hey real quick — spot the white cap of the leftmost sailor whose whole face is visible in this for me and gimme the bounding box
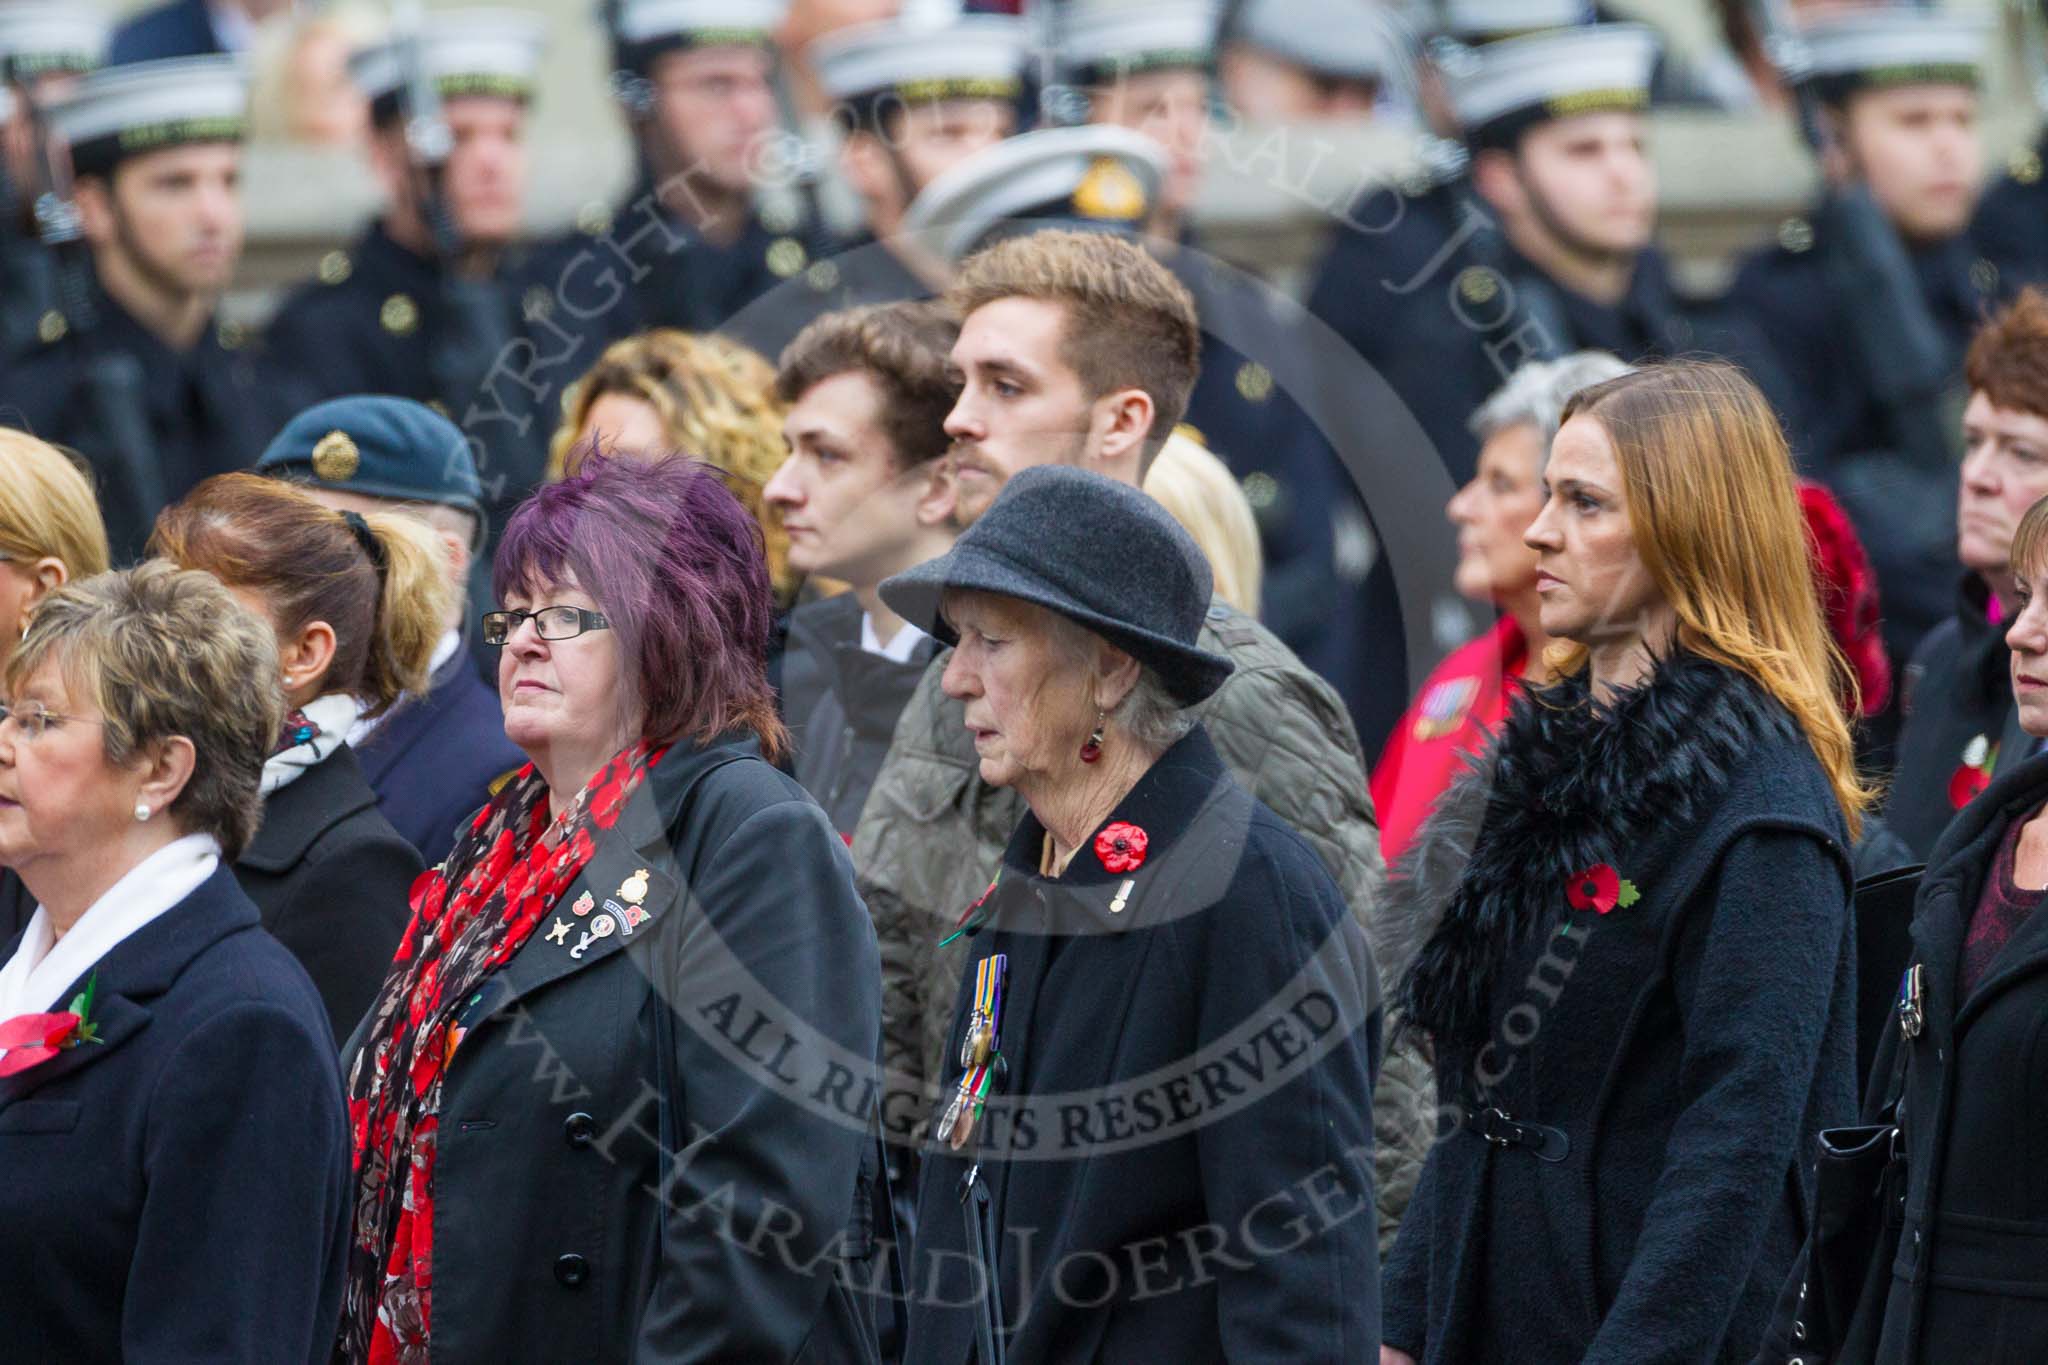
[49,55,248,174]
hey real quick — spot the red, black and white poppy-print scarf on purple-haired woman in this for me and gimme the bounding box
[334,741,664,1365]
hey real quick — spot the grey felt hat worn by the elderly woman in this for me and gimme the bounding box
[881,465,1233,706]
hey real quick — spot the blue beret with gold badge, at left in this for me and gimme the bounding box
[256,393,483,518]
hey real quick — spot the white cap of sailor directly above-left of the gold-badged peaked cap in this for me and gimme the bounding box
[809,14,1030,112]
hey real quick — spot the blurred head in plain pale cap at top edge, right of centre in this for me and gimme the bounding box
[1219,0,1407,123]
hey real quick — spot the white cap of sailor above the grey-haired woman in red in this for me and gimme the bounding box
[1446,25,1657,143]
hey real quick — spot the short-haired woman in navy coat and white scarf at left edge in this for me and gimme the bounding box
[0,561,348,1361]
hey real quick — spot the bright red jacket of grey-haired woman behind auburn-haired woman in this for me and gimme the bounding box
[1372,616,1528,866]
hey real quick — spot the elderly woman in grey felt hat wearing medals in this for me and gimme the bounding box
[881,467,1378,1365]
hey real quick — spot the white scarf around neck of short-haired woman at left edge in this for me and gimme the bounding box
[0,835,221,1019]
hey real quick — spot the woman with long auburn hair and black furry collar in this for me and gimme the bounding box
[1380,362,1870,1365]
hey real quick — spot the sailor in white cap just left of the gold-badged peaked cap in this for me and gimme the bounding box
[733,10,1030,356]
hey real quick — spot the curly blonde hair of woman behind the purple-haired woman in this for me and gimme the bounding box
[547,327,799,604]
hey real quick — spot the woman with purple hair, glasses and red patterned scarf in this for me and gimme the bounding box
[336,456,881,1363]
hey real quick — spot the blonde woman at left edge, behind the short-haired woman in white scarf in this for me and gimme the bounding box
[0,428,106,943]
